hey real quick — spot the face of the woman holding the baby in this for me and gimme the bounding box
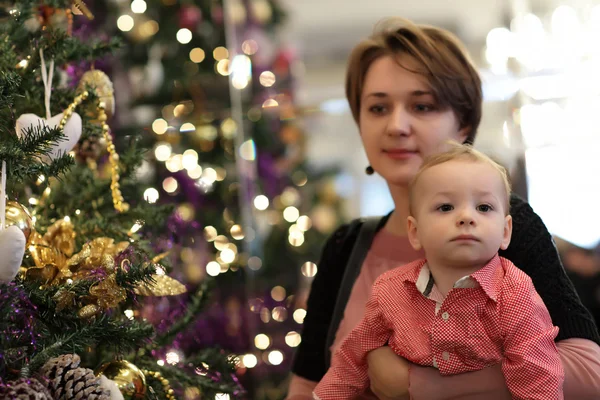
[359,56,468,186]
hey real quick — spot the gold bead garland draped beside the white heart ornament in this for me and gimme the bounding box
[58,90,129,212]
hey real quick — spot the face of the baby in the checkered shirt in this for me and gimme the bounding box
[413,160,512,267]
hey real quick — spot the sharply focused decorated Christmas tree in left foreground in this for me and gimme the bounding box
[0,0,242,399]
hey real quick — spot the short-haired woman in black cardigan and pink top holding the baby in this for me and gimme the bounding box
[288,19,600,400]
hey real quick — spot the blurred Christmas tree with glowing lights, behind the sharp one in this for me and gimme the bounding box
[93,0,340,399]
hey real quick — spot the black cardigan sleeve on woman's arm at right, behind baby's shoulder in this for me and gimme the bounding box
[500,196,600,344]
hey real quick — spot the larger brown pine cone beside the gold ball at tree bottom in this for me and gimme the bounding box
[41,354,110,400]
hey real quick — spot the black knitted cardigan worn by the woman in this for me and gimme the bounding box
[292,195,600,382]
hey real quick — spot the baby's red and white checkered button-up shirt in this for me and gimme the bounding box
[314,255,564,400]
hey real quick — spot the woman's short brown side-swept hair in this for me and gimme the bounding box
[346,18,483,143]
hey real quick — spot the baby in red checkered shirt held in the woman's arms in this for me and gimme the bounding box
[313,144,564,400]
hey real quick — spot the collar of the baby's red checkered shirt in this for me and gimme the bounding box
[405,254,503,301]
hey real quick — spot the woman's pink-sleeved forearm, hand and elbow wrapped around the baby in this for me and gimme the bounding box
[366,339,600,400]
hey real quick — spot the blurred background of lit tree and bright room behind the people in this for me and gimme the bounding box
[82,0,600,399]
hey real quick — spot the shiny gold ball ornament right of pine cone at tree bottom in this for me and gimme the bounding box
[96,360,146,400]
